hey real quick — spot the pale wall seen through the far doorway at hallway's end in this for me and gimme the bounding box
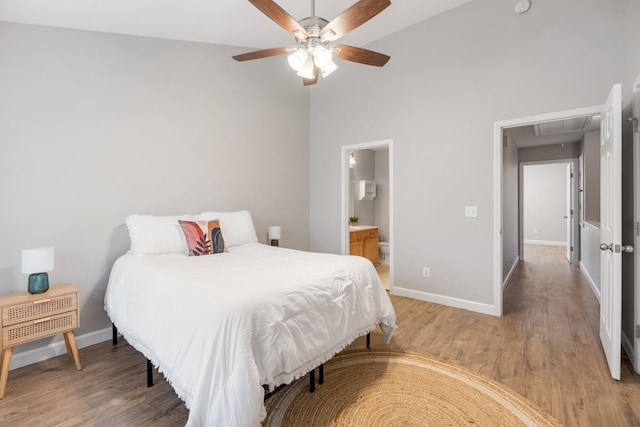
[522,163,567,244]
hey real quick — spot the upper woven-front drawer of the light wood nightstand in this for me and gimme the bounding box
[2,293,78,327]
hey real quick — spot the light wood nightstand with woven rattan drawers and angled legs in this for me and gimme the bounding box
[0,284,82,399]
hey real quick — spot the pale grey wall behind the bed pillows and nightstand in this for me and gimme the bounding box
[0,22,309,354]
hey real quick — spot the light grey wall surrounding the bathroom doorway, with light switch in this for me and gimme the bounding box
[311,0,623,312]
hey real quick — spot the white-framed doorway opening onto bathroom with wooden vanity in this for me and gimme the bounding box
[340,140,394,293]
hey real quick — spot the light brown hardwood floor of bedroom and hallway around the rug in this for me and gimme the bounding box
[0,246,640,426]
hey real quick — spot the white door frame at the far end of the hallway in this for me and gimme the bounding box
[518,157,580,265]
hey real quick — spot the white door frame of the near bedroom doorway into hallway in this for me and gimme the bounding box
[493,105,602,316]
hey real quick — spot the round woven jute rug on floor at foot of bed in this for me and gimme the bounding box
[263,350,560,427]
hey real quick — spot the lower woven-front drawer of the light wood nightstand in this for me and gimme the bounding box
[2,311,78,348]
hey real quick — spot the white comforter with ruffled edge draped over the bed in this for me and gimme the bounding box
[105,243,396,427]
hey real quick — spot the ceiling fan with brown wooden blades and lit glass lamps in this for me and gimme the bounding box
[233,0,391,86]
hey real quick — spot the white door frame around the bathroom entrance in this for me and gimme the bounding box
[340,139,395,294]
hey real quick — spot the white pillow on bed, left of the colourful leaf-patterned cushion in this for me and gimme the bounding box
[126,215,197,255]
